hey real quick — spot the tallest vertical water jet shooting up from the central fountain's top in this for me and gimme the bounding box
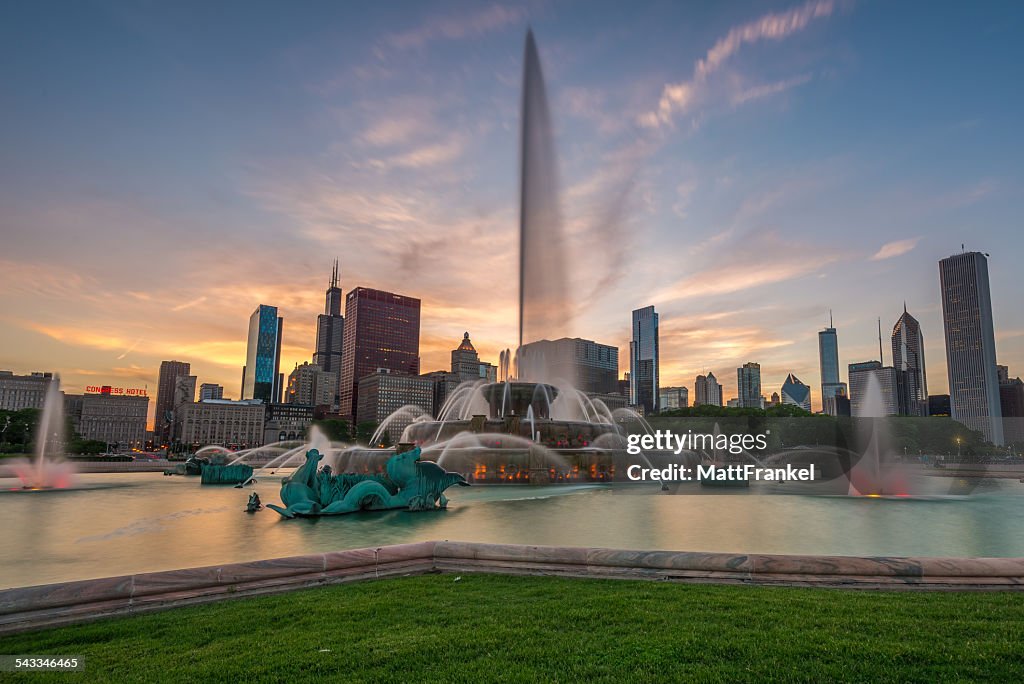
[514,31,571,382]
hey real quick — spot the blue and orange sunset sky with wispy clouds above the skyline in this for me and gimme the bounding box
[0,0,1024,421]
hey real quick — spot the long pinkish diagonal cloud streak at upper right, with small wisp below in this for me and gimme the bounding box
[639,0,836,128]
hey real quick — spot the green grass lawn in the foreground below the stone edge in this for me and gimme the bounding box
[0,574,1024,682]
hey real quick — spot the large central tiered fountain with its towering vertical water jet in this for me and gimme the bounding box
[391,31,655,483]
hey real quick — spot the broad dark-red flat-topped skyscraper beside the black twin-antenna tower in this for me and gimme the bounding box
[338,288,420,417]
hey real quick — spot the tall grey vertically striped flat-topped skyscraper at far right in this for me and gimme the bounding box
[939,252,1002,445]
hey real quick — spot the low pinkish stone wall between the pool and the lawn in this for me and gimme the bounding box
[0,542,1024,634]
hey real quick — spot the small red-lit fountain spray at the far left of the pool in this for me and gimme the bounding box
[9,377,76,490]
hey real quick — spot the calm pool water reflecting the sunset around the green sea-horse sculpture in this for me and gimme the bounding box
[0,473,1024,587]
